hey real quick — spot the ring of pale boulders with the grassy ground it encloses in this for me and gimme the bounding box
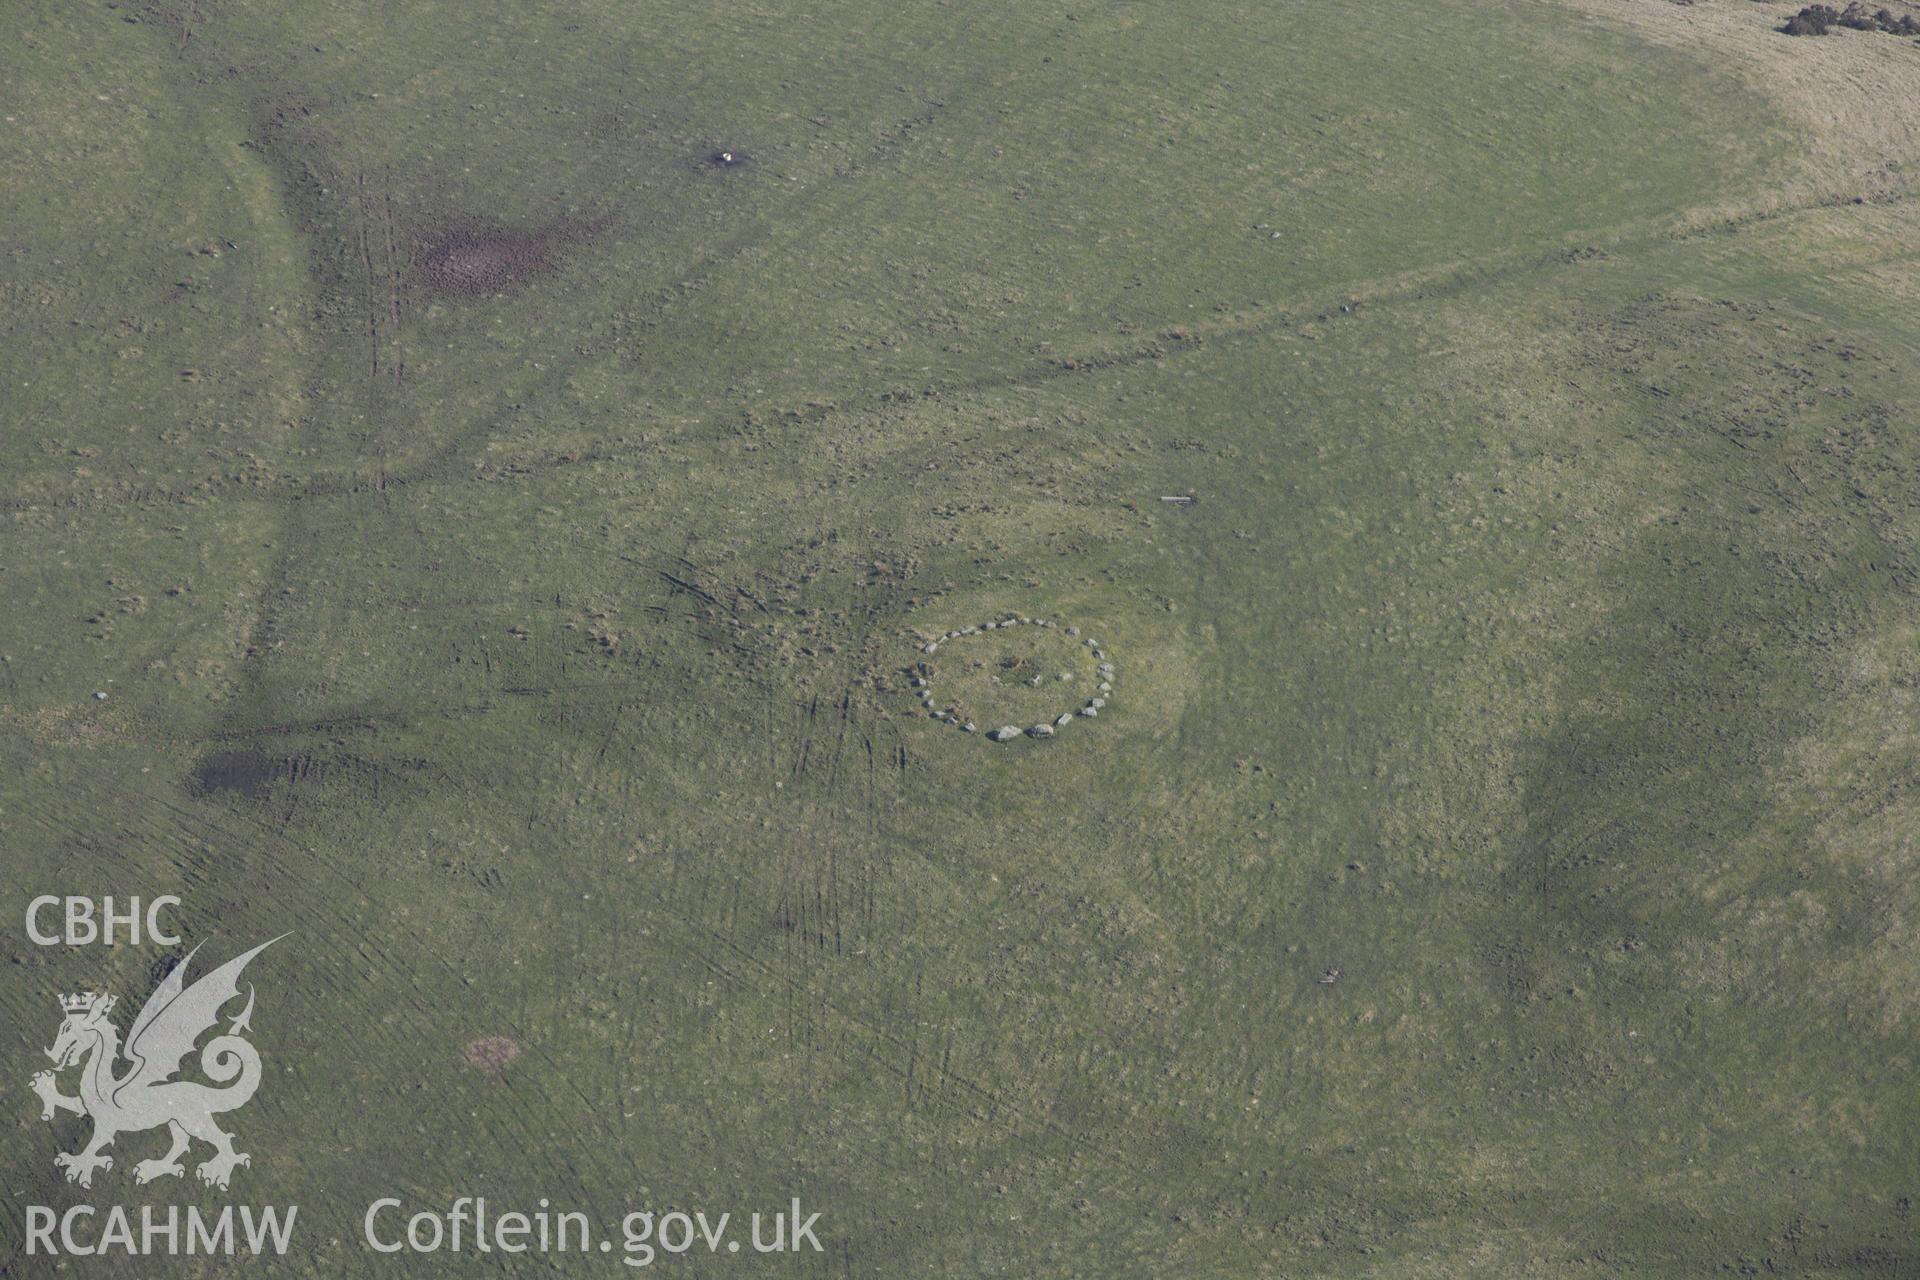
[908,614,1114,743]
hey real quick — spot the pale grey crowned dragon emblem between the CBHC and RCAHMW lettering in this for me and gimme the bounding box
[33,935,286,1188]
